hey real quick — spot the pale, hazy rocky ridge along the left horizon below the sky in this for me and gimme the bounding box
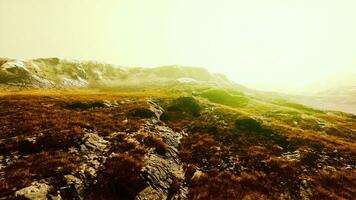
[0,58,234,88]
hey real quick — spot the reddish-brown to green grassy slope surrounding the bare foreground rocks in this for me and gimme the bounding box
[0,86,356,199]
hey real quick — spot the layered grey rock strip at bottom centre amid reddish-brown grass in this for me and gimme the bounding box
[137,122,188,200]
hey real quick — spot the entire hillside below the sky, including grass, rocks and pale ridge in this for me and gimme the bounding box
[0,59,356,200]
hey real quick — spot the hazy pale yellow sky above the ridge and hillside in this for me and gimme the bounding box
[0,0,356,91]
